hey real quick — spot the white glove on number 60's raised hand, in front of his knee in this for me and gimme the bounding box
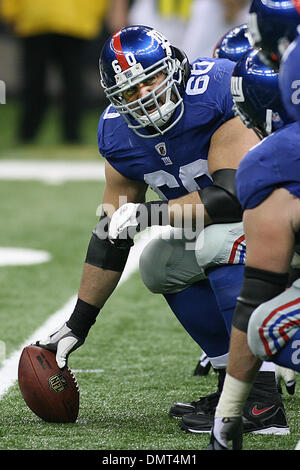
[108,202,140,244]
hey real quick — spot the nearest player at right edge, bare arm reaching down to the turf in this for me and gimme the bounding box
[208,0,300,450]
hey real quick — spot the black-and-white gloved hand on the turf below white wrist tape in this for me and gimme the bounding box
[206,417,243,450]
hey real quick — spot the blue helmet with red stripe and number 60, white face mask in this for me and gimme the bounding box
[99,26,190,138]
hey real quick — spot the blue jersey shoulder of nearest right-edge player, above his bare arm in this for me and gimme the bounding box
[236,123,300,210]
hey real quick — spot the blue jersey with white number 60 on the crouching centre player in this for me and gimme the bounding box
[98,58,235,200]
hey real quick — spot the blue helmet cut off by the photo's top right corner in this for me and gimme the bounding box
[248,0,300,70]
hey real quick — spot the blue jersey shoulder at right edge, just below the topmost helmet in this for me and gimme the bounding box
[279,36,300,122]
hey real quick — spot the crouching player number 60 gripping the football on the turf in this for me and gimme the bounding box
[39,22,286,430]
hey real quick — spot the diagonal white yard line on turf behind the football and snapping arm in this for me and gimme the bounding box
[0,227,161,399]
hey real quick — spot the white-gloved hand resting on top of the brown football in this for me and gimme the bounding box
[35,323,84,369]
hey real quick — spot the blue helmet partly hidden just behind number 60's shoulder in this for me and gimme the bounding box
[213,24,251,62]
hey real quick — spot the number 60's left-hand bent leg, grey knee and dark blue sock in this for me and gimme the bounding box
[140,229,229,367]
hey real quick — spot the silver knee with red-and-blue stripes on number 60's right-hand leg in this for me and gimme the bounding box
[195,222,246,269]
